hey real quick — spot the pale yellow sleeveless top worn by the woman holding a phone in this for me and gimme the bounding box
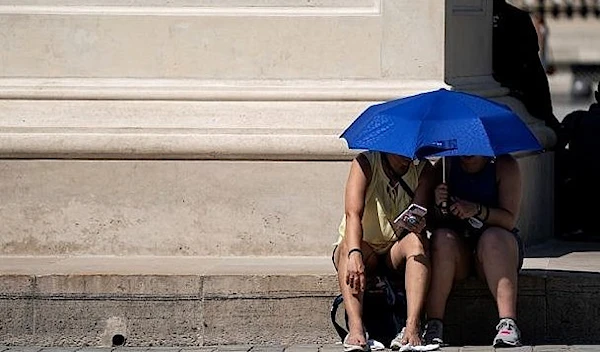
[334,152,426,254]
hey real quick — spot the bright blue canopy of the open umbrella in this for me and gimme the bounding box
[340,89,542,158]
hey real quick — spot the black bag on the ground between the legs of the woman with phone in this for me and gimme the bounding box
[331,276,406,346]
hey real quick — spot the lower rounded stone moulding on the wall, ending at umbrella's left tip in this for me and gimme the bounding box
[0,129,356,161]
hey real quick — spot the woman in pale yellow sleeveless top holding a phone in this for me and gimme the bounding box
[333,151,435,352]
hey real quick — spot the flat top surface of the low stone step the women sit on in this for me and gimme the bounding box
[0,240,600,277]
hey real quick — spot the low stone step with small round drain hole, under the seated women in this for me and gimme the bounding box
[0,242,600,346]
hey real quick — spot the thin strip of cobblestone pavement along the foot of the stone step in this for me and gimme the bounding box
[0,344,600,352]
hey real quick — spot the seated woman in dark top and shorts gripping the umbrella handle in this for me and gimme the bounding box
[424,155,523,347]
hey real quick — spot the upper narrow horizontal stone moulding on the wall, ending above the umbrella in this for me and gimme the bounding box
[0,78,448,102]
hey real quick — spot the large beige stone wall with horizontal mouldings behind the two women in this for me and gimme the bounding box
[0,0,553,255]
